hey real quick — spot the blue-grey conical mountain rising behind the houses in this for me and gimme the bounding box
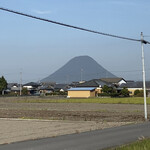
[42,56,116,83]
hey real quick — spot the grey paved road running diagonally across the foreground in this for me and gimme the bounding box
[0,122,150,150]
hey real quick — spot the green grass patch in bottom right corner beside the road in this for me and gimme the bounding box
[110,139,150,150]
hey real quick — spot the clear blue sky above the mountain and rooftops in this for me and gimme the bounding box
[0,0,150,83]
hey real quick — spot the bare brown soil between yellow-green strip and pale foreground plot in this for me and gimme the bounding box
[0,97,150,122]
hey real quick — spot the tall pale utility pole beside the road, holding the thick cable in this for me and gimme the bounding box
[141,32,147,120]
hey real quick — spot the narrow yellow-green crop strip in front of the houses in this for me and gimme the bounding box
[13,97,150,104]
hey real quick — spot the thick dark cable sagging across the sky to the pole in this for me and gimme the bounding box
[0,7,150,44]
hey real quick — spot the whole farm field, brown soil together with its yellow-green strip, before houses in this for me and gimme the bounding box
[0,97,150,122]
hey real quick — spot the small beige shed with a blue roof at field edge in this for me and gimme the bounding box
[68,87,95,98]
